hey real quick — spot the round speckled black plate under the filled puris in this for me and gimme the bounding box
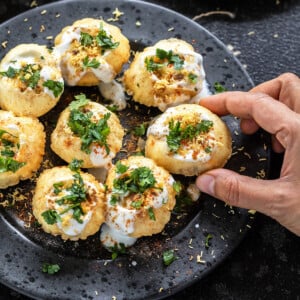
[0,0,269,299]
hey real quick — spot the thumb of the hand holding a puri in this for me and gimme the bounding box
[196,169,276,216]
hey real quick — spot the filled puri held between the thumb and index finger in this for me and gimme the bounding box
[145,104,232,176]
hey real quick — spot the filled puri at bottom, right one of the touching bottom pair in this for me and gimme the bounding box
[106,156,176,238]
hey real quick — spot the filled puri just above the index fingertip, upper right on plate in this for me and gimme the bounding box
[124,38,205,111]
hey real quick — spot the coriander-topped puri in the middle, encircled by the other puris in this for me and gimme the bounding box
[51,100,124,168]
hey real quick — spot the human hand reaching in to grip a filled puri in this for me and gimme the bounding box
[196,73,300,236]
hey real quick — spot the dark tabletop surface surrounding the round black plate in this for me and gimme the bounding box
[0,0,300,299]
